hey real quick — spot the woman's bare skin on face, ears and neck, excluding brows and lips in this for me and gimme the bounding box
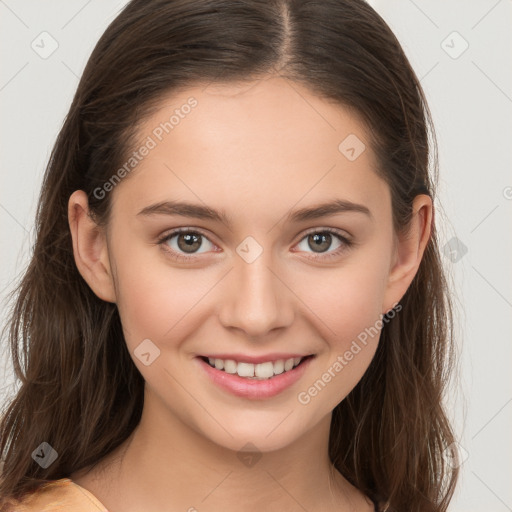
[69,77,432,512]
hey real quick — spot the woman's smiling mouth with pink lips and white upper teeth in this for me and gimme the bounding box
[194,354,315,400]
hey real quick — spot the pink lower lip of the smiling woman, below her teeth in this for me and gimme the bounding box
[195,356,314,400]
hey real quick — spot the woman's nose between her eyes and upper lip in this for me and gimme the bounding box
[219,251,294,340]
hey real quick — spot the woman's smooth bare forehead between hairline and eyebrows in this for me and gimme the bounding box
[114,78,387,226]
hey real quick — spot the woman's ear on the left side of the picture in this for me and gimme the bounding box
[68,190,116,303]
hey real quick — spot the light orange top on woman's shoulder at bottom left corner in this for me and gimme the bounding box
[6,478,108,512]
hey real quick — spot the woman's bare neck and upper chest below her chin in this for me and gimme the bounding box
[73,388,371,512]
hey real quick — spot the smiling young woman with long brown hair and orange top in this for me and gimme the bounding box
[0,0,457,512]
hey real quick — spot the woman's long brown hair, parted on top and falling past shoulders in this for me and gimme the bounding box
[0,0,457,512]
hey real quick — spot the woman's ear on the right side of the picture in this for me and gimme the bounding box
[382,194,434,314]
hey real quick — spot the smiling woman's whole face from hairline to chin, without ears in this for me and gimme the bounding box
[70,78,426,451]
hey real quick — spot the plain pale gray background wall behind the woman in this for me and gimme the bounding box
[0,0,512,512]
